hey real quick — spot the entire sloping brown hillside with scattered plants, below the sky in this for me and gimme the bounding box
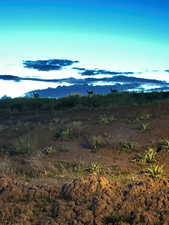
[0,92,169,225]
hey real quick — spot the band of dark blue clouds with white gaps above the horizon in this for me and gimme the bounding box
[0,59,169,97]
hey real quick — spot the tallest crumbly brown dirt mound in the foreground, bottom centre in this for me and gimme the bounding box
[58,174,118,225]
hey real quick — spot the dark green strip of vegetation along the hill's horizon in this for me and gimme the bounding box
[0,92,169,114]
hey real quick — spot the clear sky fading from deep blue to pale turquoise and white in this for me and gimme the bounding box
[0,0,169,96]
